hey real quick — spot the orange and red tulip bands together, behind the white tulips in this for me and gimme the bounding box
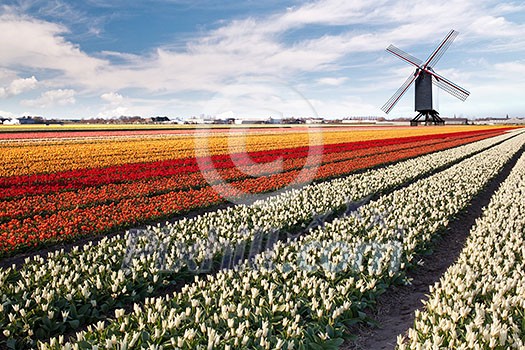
[0,128,504,256]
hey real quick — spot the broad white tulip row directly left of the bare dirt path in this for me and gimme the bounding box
[37,130,525,349]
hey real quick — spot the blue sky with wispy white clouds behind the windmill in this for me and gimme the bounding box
[0,0,525,119]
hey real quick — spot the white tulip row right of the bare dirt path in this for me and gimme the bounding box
[398,152,525,349]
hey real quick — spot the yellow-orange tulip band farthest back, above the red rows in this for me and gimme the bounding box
[0,127,506,177]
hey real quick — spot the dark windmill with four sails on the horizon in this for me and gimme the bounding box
[381,30,470,125]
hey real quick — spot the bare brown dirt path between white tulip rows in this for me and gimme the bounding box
[341,144,524,350]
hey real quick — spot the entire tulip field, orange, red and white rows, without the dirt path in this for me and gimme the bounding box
[0,126,525,349]
